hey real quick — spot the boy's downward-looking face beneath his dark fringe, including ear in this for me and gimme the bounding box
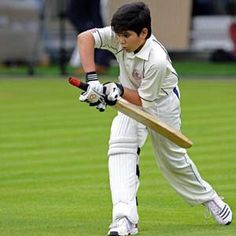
[116,28,148,52]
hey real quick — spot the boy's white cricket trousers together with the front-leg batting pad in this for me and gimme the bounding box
[108,87,217,224]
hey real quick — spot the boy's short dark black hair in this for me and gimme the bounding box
[111,2,152,38]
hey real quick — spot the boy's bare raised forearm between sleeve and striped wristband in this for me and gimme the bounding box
[77,31,96,73]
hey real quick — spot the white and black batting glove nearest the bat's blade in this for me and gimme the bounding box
[103,82,124,106]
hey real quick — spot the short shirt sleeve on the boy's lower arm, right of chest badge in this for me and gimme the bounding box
[138,60,167,108]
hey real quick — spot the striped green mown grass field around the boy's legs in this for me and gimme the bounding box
[0,78,236,236]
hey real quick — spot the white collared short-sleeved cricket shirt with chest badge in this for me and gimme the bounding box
[92,26,178,108]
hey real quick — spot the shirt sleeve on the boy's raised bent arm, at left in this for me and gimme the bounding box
[92,26,119,54]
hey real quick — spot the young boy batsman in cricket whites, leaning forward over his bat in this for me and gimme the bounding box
[78,2,232,236]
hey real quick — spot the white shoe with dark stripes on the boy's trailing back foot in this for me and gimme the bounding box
[204,196,233,225]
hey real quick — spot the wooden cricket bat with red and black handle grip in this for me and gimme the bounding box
[69,77,193,148]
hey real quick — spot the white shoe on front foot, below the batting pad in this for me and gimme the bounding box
[108,217,138,236]
